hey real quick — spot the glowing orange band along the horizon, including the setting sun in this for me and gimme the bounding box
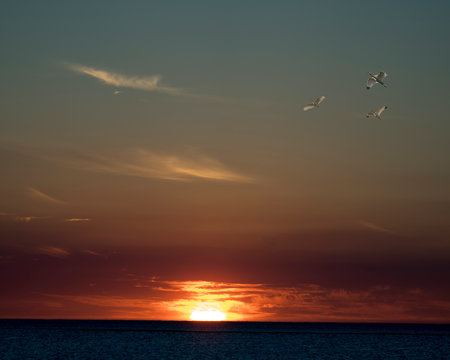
[0,278,448,323]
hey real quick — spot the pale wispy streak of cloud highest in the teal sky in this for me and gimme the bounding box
[67,64,184,95]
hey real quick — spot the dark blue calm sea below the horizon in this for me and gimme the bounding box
[0,320,450,360]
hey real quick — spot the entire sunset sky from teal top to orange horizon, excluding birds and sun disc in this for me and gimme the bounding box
[0,0,450,323]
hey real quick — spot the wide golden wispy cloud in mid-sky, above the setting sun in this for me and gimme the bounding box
[51,149,254,183]
